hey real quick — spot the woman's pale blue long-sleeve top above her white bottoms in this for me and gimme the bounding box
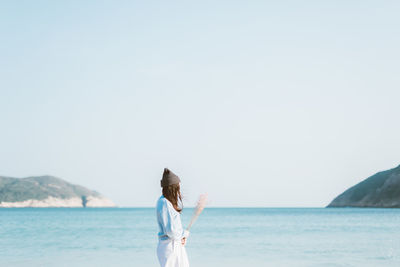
[157,195,189,240]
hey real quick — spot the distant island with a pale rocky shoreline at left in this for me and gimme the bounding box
[0,175,115,208]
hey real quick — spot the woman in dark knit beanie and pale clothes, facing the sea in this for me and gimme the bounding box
[157,168,189,267]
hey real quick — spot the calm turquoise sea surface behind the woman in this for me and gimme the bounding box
[0,208,400,267]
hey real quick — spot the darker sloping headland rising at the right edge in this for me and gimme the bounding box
[327,165,400,208]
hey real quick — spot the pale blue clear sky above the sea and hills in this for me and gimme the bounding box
[0,0,400,207]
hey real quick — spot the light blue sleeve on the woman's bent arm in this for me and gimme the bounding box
[160,202,184,240]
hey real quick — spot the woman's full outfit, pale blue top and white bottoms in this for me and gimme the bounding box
[157,196,189,267]
